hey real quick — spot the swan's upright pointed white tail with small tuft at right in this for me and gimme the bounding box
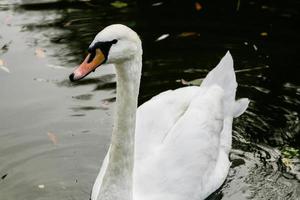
[201,51,249,117]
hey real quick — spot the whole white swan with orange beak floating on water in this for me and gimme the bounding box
[70,24,249,200]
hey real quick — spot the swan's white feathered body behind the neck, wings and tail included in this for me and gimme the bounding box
[134,53,248,200]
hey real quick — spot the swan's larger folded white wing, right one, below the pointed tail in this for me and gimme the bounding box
[134,86,231,200]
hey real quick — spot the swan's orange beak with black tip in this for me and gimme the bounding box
[69,49,105,81]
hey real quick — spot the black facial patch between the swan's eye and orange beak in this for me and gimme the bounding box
[88,39,118,63]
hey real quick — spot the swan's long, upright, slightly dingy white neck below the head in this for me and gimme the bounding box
[98,56,142,200]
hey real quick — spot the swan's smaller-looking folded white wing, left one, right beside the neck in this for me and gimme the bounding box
[135,87,199,159]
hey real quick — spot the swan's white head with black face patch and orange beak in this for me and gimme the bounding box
[69,24,142,81]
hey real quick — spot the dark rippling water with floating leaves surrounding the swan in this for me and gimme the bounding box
[0,0,300,200]
